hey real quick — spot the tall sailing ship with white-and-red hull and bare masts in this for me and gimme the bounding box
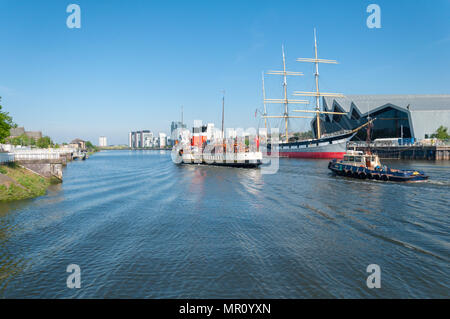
[263,30,367,159]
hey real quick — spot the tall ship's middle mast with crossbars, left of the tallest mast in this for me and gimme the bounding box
[263,47,311,143]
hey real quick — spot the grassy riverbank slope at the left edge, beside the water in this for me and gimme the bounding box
[0,163,60,202]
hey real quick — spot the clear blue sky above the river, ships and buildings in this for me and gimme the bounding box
[0,0,450,144]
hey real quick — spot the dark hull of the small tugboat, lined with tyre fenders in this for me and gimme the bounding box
[328,160,428,182]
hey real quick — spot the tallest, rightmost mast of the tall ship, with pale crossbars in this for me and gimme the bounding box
[294,28,347,139]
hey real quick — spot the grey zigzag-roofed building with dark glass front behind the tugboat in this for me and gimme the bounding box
[311,95,450,140]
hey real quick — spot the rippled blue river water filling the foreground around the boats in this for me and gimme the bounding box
[0,151,450,298]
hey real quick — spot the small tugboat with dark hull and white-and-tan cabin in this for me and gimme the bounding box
[328,116,428,182]
